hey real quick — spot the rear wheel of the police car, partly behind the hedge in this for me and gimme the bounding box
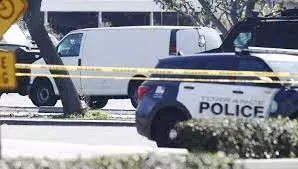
[152,112,187,148]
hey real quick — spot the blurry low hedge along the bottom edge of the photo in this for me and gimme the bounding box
[0,154,232,169]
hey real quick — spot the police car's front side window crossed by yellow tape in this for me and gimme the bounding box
[236,57,278,88]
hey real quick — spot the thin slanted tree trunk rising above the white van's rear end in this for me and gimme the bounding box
[198,0,228,36]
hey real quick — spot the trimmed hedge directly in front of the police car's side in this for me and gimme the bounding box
[176,118,298,159]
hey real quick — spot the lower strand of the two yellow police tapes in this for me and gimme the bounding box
[16,73,298,84]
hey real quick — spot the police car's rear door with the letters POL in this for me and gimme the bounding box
[177,56,239,118]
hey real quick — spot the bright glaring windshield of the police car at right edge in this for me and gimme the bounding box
[258,54,298,86]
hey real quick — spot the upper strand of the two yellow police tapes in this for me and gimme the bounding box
[15,63,298,77]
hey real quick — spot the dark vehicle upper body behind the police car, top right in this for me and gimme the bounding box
[207,9,298,53]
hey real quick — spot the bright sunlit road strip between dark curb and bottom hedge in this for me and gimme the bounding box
[2,125,155,146]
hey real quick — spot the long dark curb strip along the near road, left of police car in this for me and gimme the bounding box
[0,118,135,127]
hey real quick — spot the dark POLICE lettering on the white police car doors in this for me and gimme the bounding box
[199,96,265,118]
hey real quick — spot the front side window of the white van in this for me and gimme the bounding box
[57,33,83,57]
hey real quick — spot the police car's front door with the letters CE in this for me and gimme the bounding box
[236,56,280,117]
